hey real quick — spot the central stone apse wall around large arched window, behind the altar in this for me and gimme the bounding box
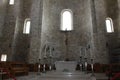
[41,0,92,60]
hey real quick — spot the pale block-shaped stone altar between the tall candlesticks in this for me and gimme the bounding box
[55,61,77,72]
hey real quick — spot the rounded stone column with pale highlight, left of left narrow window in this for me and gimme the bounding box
[11,0,24,61]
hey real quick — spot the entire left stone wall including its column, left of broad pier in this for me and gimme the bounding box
[0,0,31,62]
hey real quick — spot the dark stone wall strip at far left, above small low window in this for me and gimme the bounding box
[0,0,15,60]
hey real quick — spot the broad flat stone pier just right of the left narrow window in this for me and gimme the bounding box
[28,0,43,63]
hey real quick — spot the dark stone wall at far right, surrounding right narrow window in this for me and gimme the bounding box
[106,0,120,50]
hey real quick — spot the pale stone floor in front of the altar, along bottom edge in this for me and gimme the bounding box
[7,71,108,80]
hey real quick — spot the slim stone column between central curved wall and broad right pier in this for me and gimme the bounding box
[89,0,97,59]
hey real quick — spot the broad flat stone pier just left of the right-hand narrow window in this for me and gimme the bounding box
[91,0,109,63]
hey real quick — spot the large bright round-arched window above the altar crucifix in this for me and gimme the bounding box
[61,9,73,31]
